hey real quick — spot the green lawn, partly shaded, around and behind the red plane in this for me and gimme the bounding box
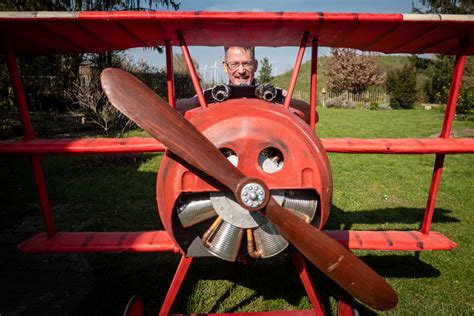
[0,109,474,315]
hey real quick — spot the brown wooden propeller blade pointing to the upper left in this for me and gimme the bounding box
[100,68,246,193]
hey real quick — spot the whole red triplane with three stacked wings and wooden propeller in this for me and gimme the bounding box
[0,12,474,315]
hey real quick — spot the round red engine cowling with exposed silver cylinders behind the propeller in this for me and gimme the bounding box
[157,99,332,261]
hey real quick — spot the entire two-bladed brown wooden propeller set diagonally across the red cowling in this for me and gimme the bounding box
[101,68,398,310]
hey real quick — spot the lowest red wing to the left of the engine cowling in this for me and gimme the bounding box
[18,230,179,253]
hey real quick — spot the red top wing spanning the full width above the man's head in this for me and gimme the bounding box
[0,11,474,54]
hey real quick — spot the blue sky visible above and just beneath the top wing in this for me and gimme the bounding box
[126,0,419,82]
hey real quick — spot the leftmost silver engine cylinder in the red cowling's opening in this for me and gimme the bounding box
[176,193,217,227]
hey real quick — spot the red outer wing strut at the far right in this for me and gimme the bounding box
[421,37,469,234]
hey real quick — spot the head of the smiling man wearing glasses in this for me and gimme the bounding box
[223,46,258,85]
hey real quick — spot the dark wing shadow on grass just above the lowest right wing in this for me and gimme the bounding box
[325,204,459,230]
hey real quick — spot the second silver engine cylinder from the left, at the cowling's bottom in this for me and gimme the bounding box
[203,221,244,261]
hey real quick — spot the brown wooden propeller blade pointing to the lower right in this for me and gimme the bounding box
[265,198,398,311]
